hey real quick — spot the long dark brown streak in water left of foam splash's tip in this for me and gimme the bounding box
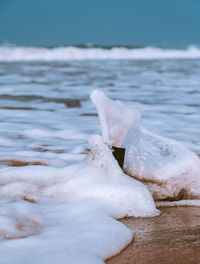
[0,94,84,108]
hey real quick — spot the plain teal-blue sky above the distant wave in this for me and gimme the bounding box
[0,0,200,47]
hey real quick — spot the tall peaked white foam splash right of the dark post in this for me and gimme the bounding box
[91,90,200,200]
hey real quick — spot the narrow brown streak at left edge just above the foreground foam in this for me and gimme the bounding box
[0,159,49,167]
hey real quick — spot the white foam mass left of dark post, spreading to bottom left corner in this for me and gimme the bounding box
[0,135,159,264]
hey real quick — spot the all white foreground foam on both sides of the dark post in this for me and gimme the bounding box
[0,90,200,264]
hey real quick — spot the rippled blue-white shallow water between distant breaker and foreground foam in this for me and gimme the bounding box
[0,59,200,167]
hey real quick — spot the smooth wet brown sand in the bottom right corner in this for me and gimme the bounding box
[106,207,200,264]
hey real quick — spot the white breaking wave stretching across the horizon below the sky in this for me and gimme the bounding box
[0,46,200,61]
